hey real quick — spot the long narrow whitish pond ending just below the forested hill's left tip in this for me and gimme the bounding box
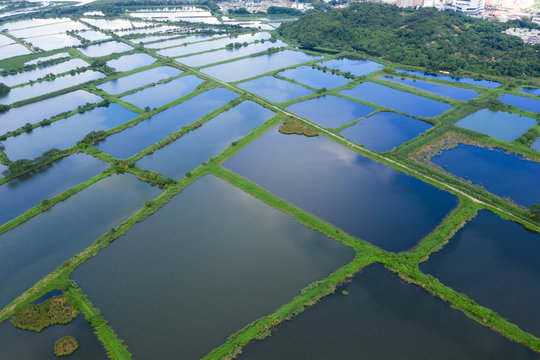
[176,40,287,67]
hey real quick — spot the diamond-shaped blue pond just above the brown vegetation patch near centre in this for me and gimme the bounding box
[287,95,375,128]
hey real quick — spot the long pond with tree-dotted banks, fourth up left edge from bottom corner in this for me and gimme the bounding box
[3,103,139,161]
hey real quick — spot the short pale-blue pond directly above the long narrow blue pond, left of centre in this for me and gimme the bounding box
[122,75,203,109]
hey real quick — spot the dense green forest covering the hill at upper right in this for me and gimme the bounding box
[278,3,540,77]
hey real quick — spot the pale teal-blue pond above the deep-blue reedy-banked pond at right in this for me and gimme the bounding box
[456,109,536,142]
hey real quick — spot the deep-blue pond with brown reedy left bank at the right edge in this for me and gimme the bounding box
[431,144,540,206]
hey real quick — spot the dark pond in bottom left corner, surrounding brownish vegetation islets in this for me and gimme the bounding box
[0,314,108,360]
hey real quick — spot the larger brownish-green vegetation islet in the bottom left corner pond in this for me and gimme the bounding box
[11,296,79,332]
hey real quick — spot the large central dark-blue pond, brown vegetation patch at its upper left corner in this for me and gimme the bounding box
[224,129,458,251]
